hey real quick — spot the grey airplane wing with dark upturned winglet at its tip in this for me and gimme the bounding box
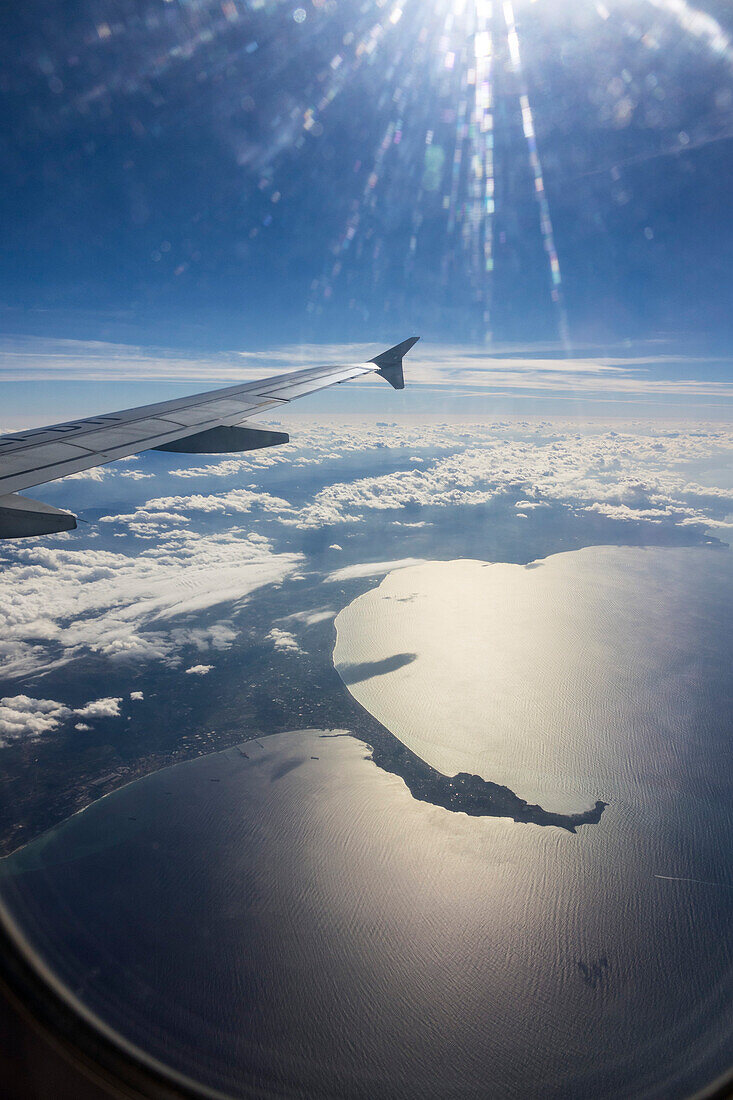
[0,337,419,539]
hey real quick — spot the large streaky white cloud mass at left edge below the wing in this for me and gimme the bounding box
[0,528,303,677]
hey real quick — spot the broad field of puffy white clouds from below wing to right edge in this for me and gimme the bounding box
[84,418,732,549]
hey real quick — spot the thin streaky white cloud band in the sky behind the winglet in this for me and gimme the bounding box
[0,337,733,399]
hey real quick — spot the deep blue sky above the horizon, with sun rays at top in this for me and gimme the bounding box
[0,0,733,416]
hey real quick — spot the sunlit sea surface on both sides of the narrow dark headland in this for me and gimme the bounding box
[0,547,733,1100]
